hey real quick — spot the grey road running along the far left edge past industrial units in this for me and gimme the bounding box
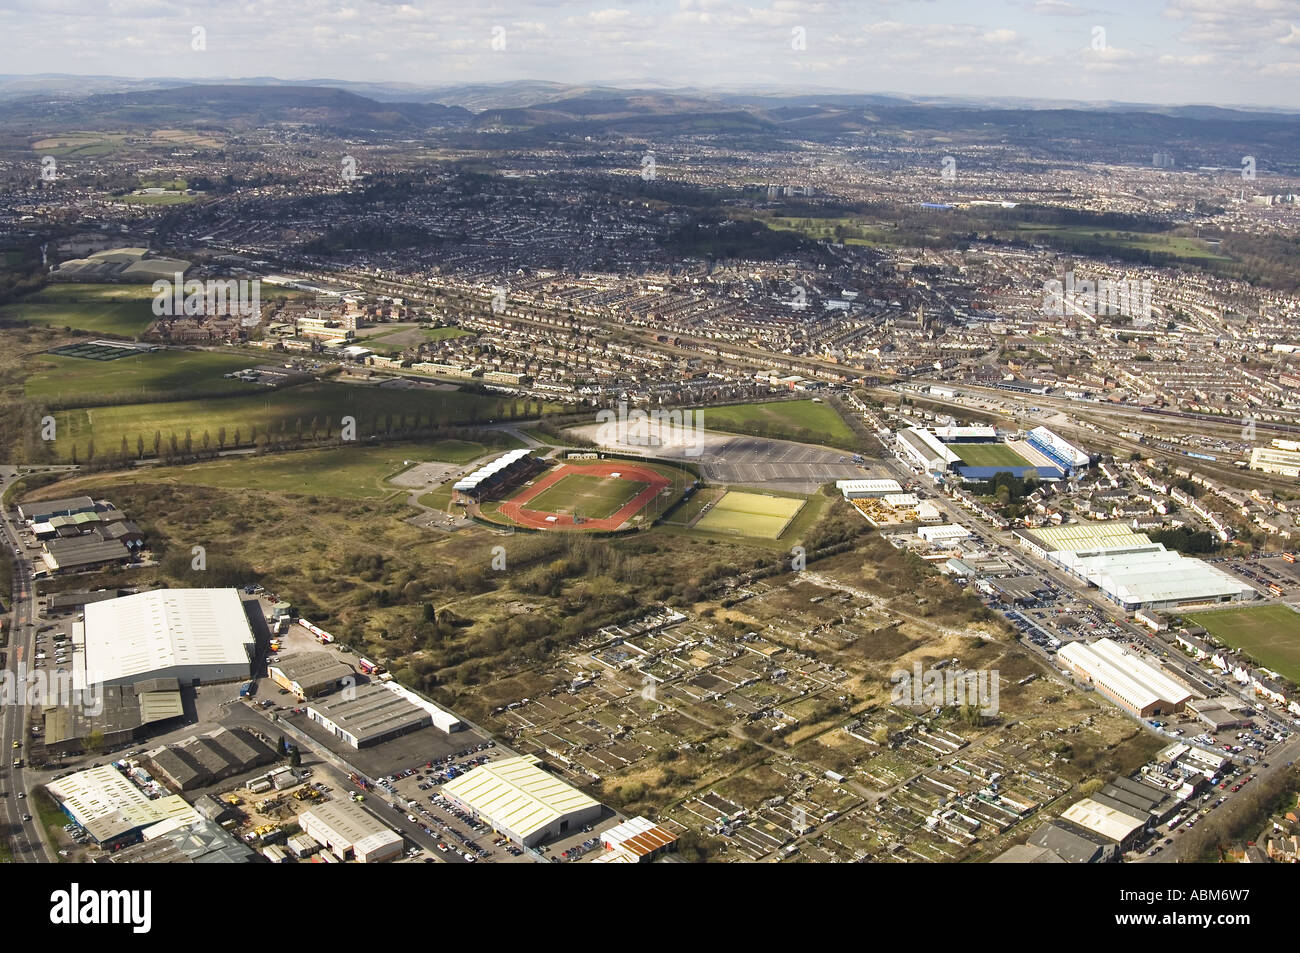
[0,468,55,863]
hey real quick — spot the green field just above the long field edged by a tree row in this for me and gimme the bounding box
[26,351,257,403]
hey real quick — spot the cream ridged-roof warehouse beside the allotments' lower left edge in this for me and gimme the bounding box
[442,754,602,848]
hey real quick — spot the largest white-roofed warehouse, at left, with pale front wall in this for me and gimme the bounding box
[73,589,256,689]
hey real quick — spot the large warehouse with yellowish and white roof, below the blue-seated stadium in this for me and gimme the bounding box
[1015,523,1258,612]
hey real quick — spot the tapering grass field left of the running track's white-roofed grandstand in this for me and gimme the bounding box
[44,439,501,499]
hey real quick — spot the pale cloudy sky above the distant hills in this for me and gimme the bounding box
[0,0,1300,107]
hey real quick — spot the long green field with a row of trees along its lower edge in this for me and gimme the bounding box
[53,382,530,462]
